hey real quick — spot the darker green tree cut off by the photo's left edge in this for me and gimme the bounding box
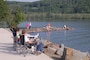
[0,0,11,26]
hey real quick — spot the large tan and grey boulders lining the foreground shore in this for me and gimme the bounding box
[42,40,90,60]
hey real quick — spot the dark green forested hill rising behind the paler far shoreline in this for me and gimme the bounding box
[7,0,90,14]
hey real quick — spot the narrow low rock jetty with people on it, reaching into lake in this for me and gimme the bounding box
[26,27,73,32]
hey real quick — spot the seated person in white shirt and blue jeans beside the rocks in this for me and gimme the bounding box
[22,30,43,53]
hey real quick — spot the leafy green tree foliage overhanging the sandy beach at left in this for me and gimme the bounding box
[0,0,25,27]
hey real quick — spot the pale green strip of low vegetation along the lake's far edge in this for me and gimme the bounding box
[26,13,90,21]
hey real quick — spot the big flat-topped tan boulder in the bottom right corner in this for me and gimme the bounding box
[65,48,89,60]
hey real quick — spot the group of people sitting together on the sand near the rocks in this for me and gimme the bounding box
[10,27,43,54]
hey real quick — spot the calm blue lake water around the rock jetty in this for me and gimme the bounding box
[18,21,90,53]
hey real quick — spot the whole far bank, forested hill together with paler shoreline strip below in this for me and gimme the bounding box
[7,0,90,21]
